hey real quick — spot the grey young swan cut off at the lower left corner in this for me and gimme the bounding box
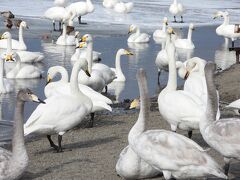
[0,89,44,180]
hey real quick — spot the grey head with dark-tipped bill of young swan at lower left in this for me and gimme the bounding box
[17,89,45,104]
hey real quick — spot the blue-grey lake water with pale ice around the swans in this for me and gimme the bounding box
[0,0,237,143]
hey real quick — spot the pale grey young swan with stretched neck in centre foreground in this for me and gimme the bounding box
[128,69,227,179]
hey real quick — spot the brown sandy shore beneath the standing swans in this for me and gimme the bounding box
[16,62,240,180]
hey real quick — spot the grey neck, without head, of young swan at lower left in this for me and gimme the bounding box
[11,97,28,163]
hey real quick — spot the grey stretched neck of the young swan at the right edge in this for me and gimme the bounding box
[200,63,218,130]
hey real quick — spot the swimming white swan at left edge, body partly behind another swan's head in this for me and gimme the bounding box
[1,32,44,63]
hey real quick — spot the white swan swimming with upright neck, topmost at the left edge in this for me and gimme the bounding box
[0,21,28,50]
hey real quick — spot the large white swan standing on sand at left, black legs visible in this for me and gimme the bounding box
[24,61,93,152]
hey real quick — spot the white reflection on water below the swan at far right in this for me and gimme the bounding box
[214,42,236,70]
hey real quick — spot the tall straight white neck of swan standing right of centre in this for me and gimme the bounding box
[166,43,177,90]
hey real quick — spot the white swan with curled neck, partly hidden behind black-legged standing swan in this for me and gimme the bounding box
[44,64,112,127]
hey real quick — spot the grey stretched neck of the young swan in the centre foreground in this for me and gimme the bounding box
[128,69,150,144]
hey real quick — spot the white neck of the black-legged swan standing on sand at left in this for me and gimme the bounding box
[70,61,84,96]
